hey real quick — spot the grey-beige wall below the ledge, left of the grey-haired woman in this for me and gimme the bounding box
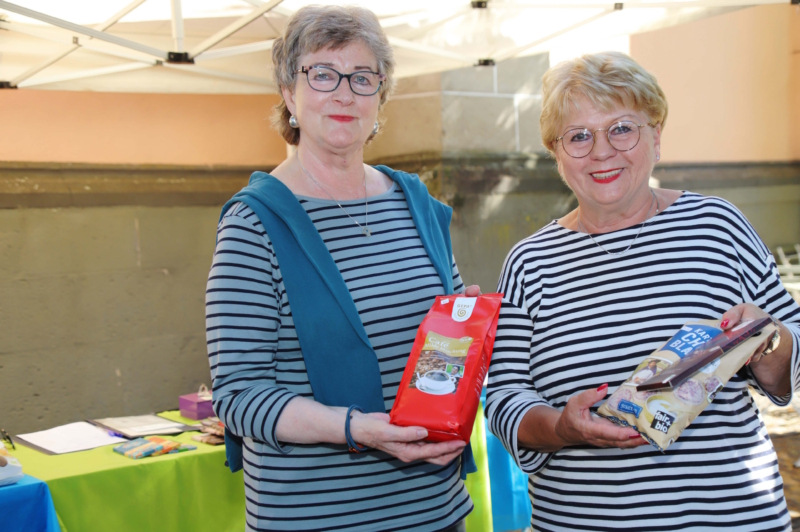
[0,206,219,433]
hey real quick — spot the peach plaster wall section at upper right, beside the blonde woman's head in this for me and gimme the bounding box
[630,4,800,163]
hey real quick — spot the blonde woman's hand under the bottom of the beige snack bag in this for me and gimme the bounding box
[555,384,647,449]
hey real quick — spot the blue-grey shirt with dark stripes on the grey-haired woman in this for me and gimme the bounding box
[206,184,472,532]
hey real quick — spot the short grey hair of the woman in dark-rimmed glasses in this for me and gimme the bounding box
[272,6,394,146]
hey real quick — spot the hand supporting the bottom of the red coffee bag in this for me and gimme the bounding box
[350,412,467,465]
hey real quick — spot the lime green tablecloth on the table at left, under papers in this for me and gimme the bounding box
[11,414,245,532]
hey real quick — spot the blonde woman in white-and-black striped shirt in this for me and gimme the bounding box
[486,52,800,532]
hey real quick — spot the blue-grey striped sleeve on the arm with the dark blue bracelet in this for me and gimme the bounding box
[206,205,295,452]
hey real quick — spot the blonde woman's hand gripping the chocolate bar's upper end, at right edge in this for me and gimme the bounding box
[720,303,792,396]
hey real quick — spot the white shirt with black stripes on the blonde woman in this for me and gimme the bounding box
[487,192,800,532]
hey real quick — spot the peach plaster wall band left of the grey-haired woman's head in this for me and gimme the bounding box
[0,89,286,167]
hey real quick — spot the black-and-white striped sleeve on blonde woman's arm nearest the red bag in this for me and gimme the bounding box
[486,244,552,474]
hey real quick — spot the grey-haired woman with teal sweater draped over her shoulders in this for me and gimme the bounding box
[206,6,479,531]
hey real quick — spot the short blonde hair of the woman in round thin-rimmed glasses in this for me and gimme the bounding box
[539,52,668,155]
